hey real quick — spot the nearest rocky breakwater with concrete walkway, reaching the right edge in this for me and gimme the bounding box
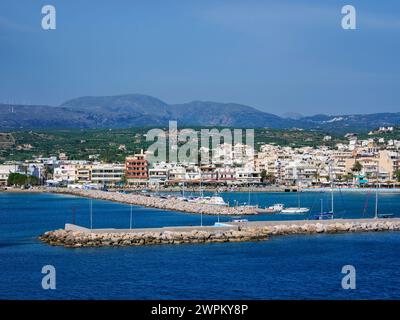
[39,219,400,248]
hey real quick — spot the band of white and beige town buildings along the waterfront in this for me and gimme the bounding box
[0,128,400,188]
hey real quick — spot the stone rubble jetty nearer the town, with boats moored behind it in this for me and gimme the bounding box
[48,188,257,215]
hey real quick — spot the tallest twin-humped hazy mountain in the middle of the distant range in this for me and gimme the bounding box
[62,94,290,128]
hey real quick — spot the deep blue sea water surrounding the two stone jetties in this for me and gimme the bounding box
[0,193,400,299]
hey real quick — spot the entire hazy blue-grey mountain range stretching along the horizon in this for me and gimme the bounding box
[0,94,400,132]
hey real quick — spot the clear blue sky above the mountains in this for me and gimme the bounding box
[0,0,400,115]
